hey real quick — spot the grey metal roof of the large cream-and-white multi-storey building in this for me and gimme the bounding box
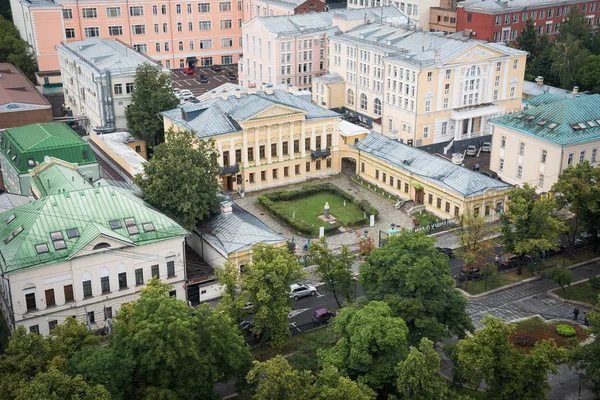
[330,23,526,67]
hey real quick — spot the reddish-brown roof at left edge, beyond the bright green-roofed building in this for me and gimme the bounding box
[0,63,50,107]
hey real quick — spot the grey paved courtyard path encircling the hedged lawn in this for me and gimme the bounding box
[235,174,412,247]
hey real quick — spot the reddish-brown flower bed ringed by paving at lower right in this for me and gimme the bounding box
[510,318,588,352]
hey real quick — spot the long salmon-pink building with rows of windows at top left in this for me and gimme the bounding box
[11,0,244,71]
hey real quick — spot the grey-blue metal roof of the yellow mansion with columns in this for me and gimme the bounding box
[161,90,339,137]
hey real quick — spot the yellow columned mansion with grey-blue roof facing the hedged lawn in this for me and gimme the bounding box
[162,85,339,192]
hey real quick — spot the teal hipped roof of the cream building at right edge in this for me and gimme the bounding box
[491,94,600,146]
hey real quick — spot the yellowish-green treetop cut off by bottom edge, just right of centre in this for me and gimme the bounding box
[316,365,377,400]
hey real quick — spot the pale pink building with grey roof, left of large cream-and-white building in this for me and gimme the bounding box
[238,6,408,89]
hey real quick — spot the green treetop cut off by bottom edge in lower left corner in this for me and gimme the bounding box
[15,367,110,400]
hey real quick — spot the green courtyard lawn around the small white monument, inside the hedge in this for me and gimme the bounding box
[272,192,364,235]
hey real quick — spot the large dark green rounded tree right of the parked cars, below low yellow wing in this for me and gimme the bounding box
[360,230,473,344]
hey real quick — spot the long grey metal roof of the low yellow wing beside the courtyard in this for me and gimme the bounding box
[354,132,511,197]
